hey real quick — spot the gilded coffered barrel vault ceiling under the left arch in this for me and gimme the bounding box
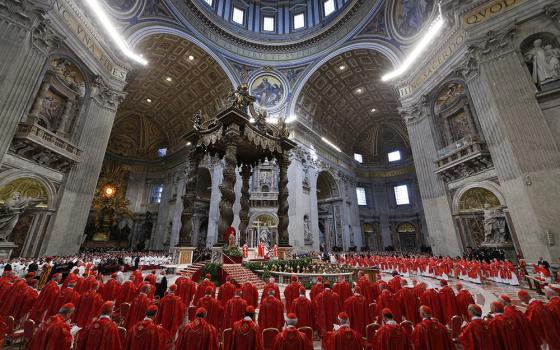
[109,35,232,158]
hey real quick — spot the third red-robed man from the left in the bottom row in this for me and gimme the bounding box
[124,305,171,350]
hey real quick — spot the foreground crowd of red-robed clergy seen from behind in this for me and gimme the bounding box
[0,258,560,350]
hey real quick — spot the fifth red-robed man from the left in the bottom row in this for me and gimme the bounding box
[228,306,263,350]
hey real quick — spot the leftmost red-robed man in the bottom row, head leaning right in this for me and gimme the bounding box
[27,303,75,350]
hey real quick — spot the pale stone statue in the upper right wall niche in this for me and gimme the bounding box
[524,39,560,85]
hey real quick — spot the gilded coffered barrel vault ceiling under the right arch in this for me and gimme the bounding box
[295,49,401,153]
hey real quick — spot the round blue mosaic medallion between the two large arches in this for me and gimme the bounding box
[249,73,286,109]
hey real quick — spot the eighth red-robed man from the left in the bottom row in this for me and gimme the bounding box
[373,309,413,350]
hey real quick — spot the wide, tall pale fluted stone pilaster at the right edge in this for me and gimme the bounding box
[464,26,560,260]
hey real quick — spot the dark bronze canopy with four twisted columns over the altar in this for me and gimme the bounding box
[173,84,296,264]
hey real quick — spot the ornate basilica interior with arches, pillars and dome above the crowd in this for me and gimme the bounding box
[0,0,560,263]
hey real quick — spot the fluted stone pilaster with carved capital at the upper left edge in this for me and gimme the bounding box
[0,0,59,164]
